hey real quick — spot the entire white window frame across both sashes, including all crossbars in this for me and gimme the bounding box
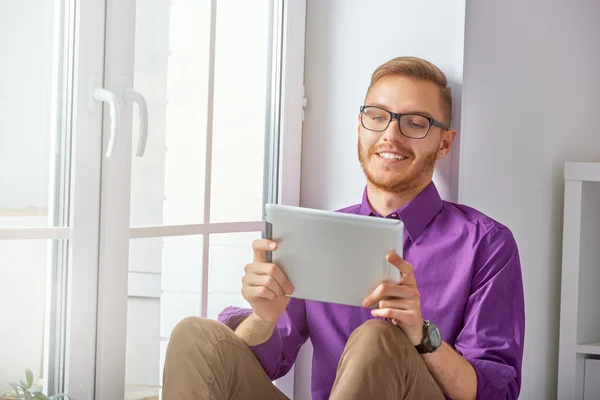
[0,0,306,398]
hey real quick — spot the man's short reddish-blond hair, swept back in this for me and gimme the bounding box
[367,57,452,126]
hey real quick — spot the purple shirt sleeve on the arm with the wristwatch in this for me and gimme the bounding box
[455,227,525,400]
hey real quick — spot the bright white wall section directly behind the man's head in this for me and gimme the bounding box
[302,0,465,400]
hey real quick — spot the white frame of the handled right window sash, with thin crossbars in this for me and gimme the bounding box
[95,0,306,399]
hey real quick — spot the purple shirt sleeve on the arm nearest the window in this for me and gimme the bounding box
[218,298,308,380]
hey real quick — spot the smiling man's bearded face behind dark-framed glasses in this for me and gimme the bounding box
[358,76,455,193]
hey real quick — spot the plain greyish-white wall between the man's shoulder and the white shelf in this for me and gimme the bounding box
[459,0,600,399]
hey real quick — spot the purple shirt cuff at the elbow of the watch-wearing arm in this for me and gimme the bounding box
[469,359,518,400]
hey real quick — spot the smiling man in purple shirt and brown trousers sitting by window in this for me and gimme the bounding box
[163,57,525,400]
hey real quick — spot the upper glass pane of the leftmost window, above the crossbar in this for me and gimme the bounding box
[0,0,68,227]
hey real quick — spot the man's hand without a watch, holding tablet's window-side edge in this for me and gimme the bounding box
[242,239,294,325]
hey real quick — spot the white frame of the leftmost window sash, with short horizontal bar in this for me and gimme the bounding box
[0,0,105,398]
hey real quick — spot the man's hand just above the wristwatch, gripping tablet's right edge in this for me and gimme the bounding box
[363,252,423,346]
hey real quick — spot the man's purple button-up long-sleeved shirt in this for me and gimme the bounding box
[219,182,525,400]
